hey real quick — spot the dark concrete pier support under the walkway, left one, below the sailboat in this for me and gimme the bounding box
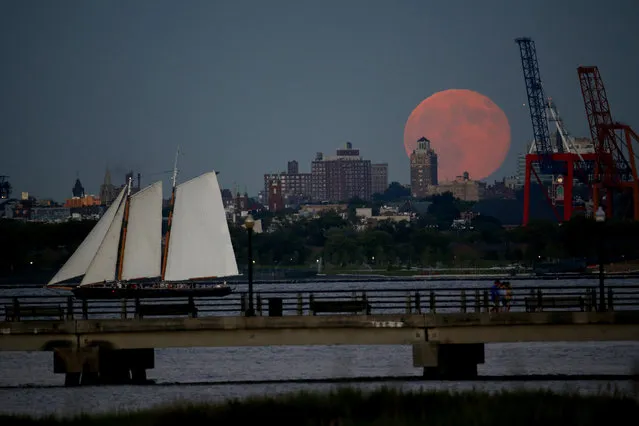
[53,346,155,386]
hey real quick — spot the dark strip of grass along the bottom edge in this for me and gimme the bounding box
[0,388,639,426]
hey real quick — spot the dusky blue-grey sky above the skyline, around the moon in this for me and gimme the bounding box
[0,0,639,201]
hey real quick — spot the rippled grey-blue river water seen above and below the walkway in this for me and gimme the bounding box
[0,280,639,416]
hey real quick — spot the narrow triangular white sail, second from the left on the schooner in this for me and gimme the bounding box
[80,193,126,286]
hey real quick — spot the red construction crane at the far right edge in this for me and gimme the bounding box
[577,66,639,220]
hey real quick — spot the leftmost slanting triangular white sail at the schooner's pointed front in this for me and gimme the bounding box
[47,188,126,286]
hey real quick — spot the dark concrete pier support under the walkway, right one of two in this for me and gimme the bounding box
[413,342,484,380]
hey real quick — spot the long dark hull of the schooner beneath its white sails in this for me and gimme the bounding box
[71,286,233,300]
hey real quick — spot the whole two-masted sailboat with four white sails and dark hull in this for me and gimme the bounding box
[47,165,238,299]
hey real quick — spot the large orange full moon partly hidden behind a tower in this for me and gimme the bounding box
[404,89,510,182]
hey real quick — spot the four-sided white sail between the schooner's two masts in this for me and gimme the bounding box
[122,181,162,280]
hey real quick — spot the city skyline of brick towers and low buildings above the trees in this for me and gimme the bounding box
[2,137,510,208]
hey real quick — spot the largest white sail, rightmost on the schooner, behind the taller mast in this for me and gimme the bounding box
[164,172,238,281]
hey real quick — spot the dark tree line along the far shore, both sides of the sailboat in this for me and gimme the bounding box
[0,196,639,276]
